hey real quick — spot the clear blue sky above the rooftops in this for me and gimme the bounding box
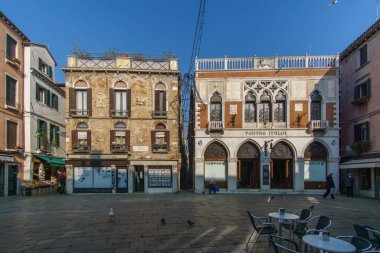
[0,0,376,82]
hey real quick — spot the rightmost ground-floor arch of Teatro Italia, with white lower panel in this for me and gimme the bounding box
[304,141,327,189]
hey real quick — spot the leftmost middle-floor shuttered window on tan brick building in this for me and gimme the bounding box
[72,122,91,152]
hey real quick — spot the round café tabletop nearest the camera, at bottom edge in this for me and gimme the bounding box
[302,235,356,253]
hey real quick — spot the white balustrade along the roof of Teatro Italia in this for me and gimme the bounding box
[195,55,339,71]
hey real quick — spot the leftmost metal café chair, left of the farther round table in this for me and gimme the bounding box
[245,210,278,252]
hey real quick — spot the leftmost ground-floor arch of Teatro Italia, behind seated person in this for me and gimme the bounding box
[204,142,228,188]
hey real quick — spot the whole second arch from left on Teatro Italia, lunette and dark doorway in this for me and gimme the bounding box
[236,141,260,189]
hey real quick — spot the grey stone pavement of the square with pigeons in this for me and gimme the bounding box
[0,193,380,253]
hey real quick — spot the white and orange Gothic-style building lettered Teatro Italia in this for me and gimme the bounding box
[189,55,339,193]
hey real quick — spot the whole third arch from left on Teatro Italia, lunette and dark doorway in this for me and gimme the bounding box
[270,142,294,189]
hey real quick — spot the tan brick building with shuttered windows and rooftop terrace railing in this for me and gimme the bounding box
[63,55,181,193]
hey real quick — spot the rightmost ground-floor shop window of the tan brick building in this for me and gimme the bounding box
[148,166,172,188]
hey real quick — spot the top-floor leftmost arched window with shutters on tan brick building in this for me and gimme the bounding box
[69,80,92,116]
